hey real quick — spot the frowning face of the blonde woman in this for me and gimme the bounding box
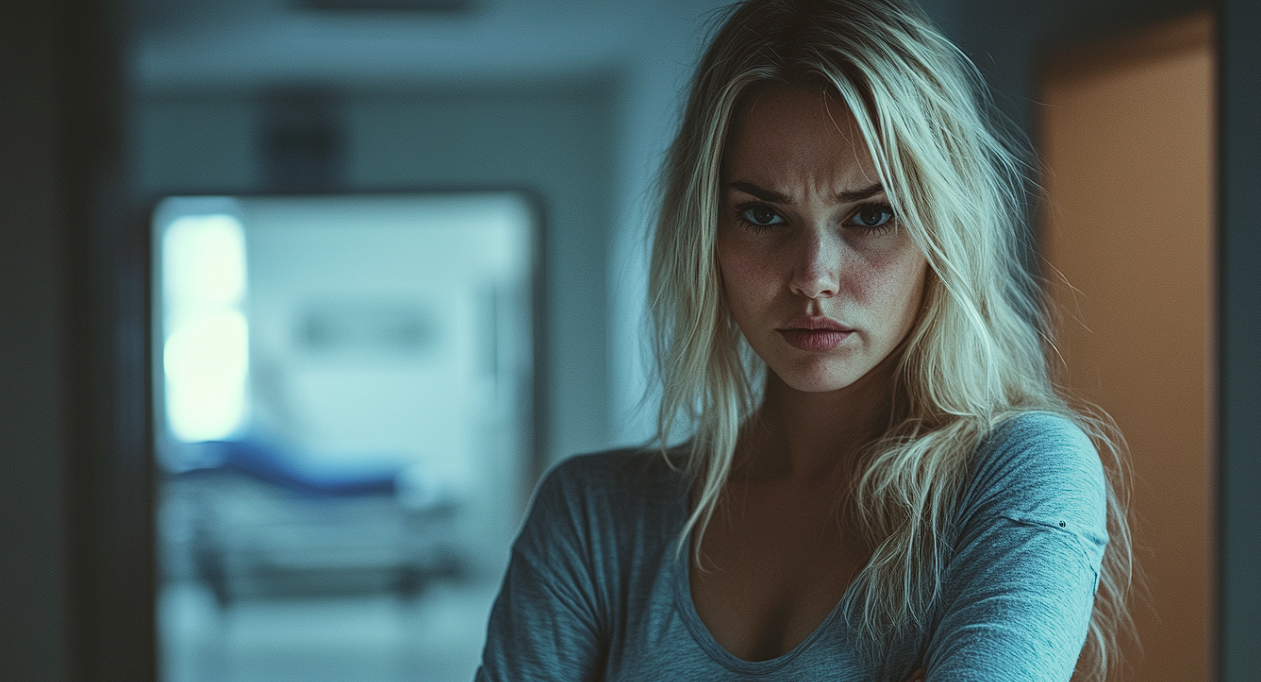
[718,86,926,392]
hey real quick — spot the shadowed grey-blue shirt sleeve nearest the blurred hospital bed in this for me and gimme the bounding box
[477,463,604,682]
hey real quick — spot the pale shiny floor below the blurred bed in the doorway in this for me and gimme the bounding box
[159,581,498,682]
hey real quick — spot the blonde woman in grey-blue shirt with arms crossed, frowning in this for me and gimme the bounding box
[478,0,1130,682]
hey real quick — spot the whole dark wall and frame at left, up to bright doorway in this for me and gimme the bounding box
[0,0,154,682]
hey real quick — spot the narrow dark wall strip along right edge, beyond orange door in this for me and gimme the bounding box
[1218,0,1261,682]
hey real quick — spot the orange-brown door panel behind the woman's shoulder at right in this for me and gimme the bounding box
[1040,15,1217,682]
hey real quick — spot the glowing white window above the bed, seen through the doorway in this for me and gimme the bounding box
[161,214,250,442]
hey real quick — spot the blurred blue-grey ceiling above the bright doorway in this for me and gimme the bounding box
[129,0,725,90]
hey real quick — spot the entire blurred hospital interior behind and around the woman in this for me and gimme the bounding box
[0,0,1261,682]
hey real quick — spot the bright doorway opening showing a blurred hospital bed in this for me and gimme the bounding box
[154,192,537,682]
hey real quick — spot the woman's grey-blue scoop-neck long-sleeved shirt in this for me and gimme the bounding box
[477,412,1107,682]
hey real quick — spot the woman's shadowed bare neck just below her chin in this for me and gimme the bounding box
[738,357,895,483]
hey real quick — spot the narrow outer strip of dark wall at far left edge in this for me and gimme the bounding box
[0,0,71,682]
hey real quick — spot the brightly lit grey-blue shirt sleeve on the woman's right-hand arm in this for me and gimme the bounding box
[924,413,1107,682]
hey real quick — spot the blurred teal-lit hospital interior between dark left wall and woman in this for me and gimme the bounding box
[126,0,736,682]
